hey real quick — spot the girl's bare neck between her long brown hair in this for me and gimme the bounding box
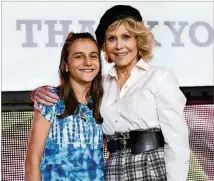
[70,80,91,104]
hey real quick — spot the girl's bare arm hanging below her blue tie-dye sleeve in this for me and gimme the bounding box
[25,111,51,181]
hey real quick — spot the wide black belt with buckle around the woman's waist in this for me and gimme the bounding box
[107,131,165,154]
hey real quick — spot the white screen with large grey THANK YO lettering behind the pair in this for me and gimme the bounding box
[2,1,214,91]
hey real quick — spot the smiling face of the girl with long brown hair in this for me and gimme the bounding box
[66,39,100,83]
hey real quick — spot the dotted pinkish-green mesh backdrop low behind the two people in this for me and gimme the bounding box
[1,105,214,181]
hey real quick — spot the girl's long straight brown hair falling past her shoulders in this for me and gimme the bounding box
[57,32,103,124]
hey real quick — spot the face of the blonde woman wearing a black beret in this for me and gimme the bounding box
[105,24,138,67]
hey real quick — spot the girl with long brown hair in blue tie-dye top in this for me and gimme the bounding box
[25,33,104,181]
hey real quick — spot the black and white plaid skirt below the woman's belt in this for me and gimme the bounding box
[105,129,167,181]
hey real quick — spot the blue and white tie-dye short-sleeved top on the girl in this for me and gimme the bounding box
[39,89,104,181]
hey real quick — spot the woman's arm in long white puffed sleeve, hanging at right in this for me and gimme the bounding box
[155,71,190,181]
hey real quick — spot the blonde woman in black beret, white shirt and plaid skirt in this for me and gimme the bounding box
[31,5,189,181]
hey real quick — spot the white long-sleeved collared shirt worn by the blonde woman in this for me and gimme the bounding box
[100,59,190,181]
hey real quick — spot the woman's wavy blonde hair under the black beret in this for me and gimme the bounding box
[102,18,155,62]
